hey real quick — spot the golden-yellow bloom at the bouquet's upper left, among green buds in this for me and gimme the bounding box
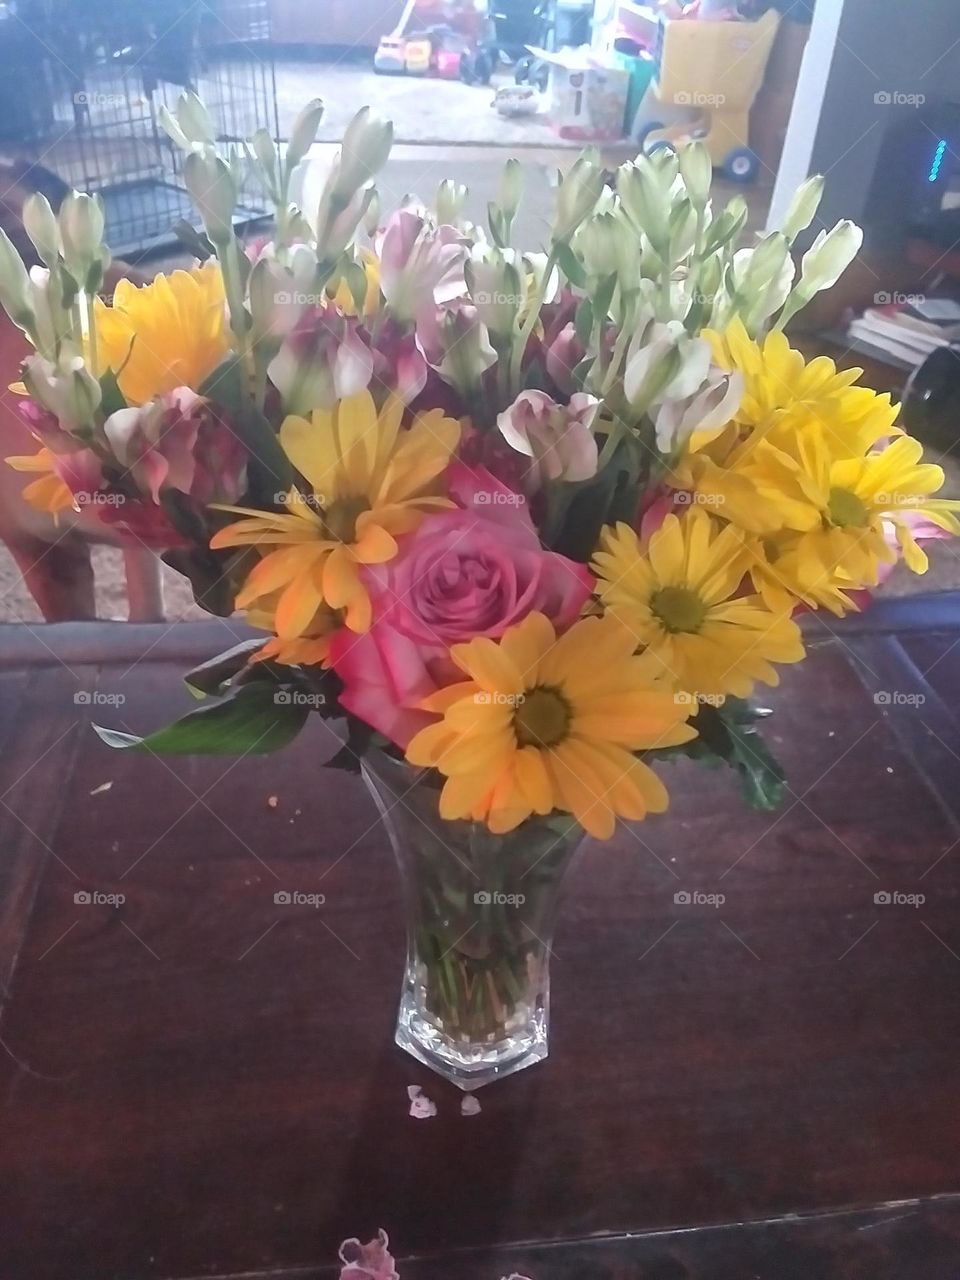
[95,259,230,404]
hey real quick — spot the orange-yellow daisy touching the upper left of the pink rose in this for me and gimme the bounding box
[210,390,460,641]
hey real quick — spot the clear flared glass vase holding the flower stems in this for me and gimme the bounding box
[364,751,584,1091]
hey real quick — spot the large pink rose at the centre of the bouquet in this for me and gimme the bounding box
[330,462,593,748]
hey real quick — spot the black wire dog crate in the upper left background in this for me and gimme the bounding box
[0,0,278,259]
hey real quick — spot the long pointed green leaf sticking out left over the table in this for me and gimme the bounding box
[93,684,310,755]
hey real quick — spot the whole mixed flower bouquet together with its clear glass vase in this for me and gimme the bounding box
[0,95,960,1087]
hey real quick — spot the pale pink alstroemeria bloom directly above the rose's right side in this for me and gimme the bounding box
[497,392,600,492]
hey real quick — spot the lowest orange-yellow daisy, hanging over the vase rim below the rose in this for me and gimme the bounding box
[407,613,696,840]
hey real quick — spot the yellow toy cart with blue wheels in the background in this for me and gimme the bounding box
[640,9,780,182]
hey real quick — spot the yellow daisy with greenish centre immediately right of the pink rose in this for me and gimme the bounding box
[593,508,804,698]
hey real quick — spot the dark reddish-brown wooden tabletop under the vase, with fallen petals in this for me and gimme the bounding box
[0,595,960,1280]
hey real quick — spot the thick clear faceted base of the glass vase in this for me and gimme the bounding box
[396,1001,548,1093]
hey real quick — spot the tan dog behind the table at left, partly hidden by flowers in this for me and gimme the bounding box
[0,164,164,622]
